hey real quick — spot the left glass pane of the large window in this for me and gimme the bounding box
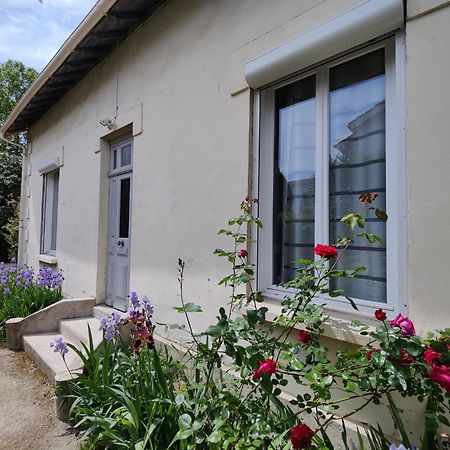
[273,76,316,284]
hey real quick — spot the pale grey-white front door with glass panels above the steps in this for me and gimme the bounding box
[106,139,133,311]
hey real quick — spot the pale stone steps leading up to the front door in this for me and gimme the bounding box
[23,305,115,382]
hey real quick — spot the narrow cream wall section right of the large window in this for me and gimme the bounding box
[406,5,450,331]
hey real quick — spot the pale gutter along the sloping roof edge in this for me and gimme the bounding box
[0,0,117,136]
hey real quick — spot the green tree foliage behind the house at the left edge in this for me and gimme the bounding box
[0,60,38,260]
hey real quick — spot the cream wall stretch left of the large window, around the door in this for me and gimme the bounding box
[27,0,361,322]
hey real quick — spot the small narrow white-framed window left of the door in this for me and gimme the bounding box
[41,170,59,256]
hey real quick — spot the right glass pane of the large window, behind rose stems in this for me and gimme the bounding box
[329,49,386,302]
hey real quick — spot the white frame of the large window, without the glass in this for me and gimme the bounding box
[252,32,407,315]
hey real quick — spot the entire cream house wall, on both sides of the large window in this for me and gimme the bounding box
[20,0,450,440]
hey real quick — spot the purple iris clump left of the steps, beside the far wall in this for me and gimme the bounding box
[0,258,63,342]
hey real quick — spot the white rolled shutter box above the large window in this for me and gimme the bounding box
[245,0,404,88]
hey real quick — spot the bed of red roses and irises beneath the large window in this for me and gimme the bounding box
[55,194,450,450]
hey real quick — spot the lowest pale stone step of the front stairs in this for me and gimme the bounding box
[23,331,83,381]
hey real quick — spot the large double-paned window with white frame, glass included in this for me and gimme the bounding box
[257,37,403,311]
